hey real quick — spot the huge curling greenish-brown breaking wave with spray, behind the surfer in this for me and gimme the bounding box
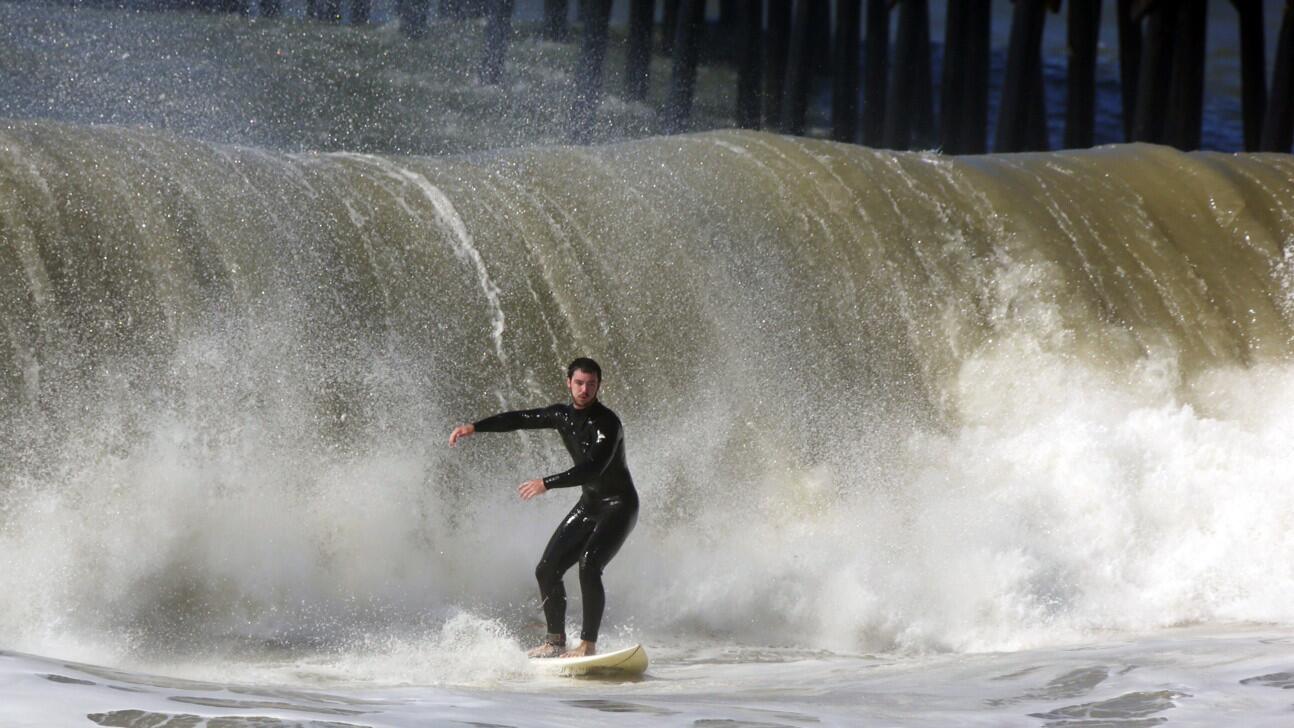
[0,123,1294,674]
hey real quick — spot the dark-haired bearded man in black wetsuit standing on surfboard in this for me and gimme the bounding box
[449,357,638,657]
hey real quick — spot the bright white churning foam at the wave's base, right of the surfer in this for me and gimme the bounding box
[608,340,1294,652]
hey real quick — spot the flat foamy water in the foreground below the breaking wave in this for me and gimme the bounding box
[0,630,1294,728]
